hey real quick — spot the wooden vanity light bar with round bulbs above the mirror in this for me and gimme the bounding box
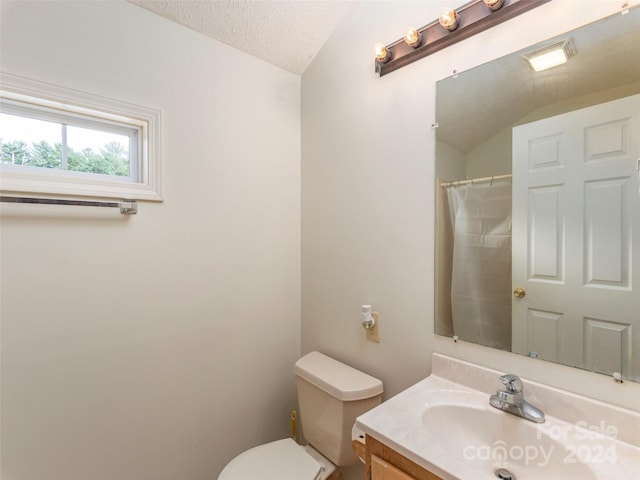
[375,0,551,77]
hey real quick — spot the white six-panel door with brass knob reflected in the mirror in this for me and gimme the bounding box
[512,95,640,380]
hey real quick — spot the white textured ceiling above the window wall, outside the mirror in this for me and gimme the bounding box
[129,0,352,74]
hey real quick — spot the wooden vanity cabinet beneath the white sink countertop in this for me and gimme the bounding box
[354,435,442,480]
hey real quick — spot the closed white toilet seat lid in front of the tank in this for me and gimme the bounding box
[218,438,324,480]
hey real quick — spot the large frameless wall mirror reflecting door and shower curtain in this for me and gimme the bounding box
[435,7,640,381]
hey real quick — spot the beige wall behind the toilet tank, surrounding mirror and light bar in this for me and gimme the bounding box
[302,0,640,409]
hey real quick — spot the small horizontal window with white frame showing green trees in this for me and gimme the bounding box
[0,74,162,200]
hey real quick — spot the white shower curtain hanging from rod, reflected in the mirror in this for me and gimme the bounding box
[448,183,511,350]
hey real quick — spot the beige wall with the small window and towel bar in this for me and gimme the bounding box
[0,1,300,480]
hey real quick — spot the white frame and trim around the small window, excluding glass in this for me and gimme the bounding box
[0,72,163,201]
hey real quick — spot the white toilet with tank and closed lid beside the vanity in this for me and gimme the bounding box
[218,352,382,480]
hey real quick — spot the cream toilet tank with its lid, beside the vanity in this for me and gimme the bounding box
[294,352,383,466]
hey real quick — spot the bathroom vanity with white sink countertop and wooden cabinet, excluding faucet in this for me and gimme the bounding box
[353,354,640,480]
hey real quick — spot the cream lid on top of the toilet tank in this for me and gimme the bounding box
[294,352,383,401]
